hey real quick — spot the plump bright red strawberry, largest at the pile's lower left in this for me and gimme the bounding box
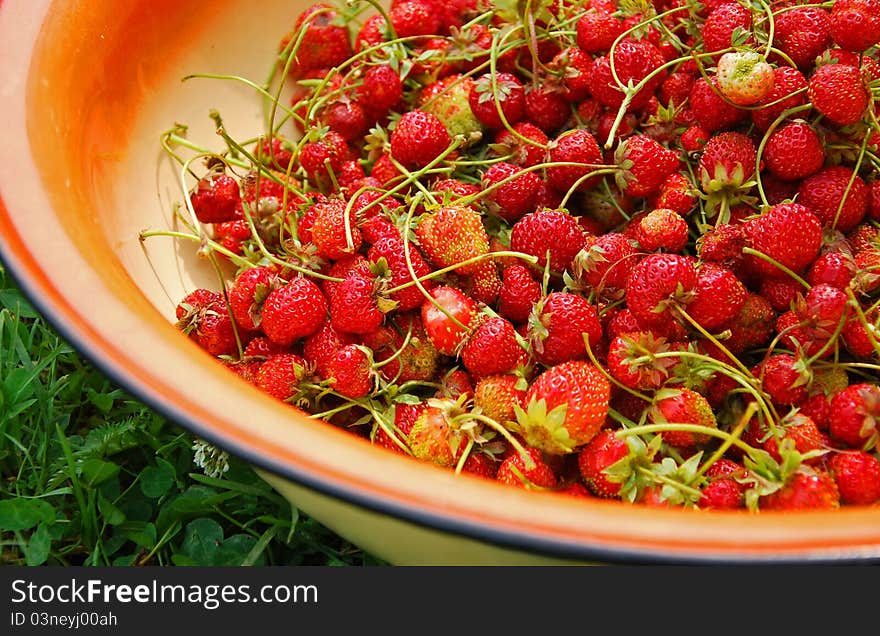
[262,276,327,345]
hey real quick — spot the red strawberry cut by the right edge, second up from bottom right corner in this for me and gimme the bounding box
[829,382,880,449]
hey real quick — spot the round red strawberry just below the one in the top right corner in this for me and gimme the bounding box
[807,64,871,126]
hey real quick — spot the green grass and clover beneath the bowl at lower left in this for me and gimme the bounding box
[0,267,381,565]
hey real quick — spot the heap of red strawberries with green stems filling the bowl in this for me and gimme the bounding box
[145,0,880,510]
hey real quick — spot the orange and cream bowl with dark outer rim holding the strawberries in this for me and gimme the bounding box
[0,0,880,564]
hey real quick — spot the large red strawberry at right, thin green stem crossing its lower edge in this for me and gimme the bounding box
[745,203,822,278]
